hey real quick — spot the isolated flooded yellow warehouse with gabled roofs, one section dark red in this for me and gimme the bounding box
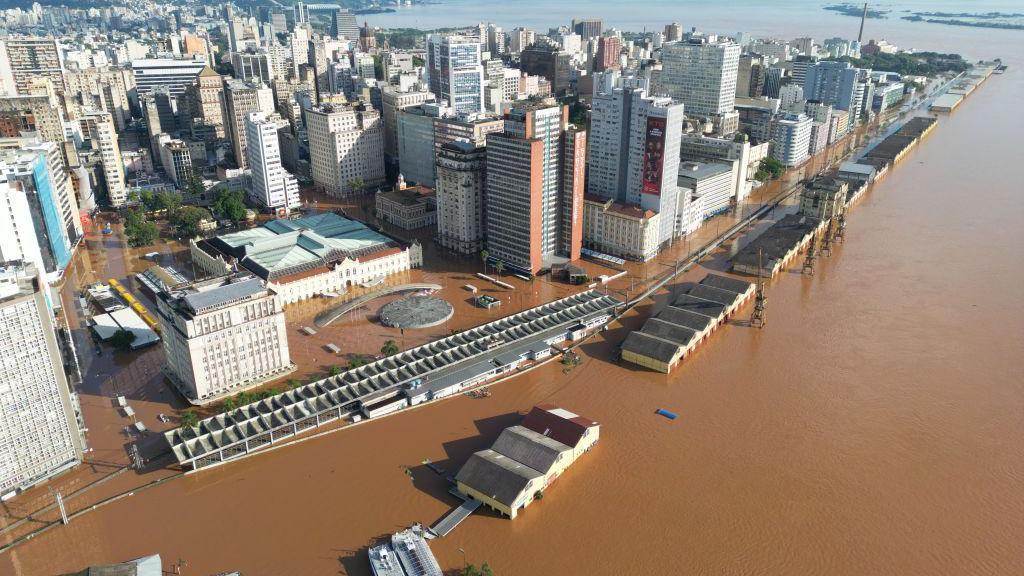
[456,404,601,519]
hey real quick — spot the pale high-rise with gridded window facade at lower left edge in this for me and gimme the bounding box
[0,262,85,500]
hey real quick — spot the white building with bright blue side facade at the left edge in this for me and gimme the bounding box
[0,138,82,282]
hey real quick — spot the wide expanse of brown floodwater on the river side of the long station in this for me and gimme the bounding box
[0,26,1024,576]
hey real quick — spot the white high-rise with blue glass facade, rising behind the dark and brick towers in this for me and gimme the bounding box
[426,34,484,114]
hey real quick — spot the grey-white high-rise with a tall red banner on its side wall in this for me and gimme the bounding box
[587,77,685,244]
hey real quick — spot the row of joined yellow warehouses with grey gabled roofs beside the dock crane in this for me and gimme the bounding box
[622,274,754,374]
